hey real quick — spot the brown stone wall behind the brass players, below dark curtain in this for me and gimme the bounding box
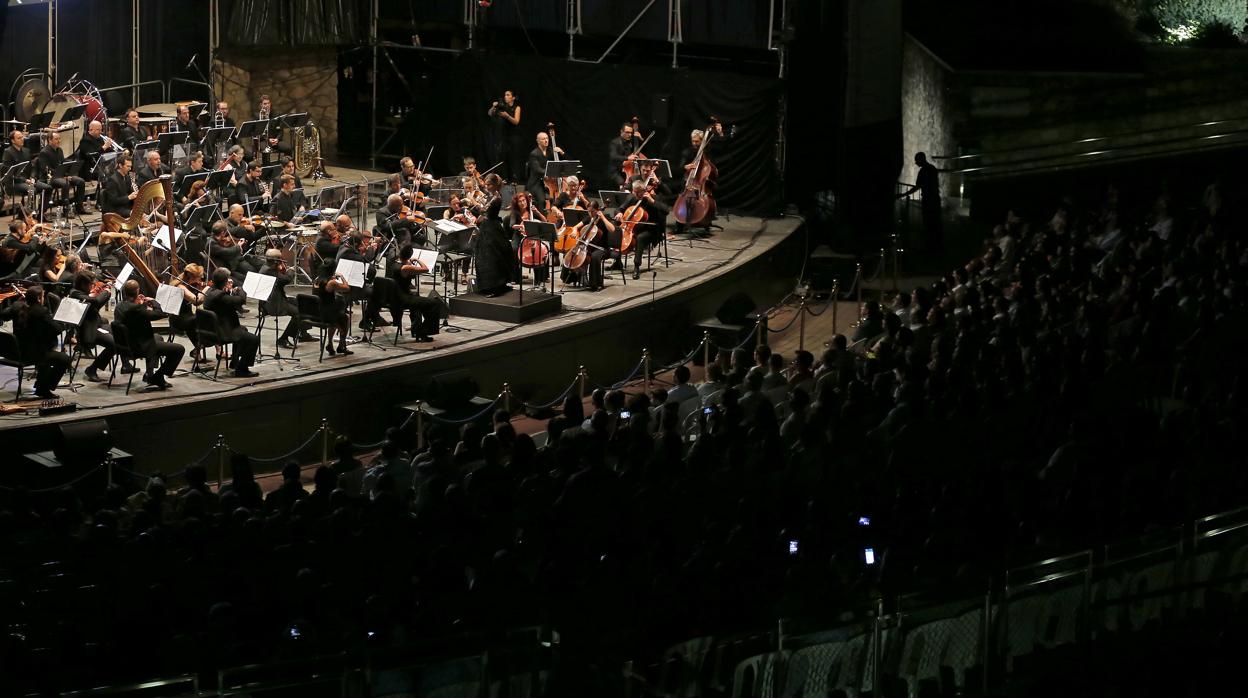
[213,47,338,159]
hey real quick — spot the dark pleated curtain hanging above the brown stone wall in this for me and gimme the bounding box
[221,0,369,46]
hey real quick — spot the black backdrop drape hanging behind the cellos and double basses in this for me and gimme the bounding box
[383,50,784,214]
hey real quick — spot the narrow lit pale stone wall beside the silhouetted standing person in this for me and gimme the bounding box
[900,35,957,196]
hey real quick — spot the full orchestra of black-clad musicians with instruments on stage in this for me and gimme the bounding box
[0,91,726,398]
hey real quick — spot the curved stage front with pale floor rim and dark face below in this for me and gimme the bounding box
[0,215,806,471]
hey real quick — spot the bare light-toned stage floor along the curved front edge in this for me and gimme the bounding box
[0,178,802,442]
